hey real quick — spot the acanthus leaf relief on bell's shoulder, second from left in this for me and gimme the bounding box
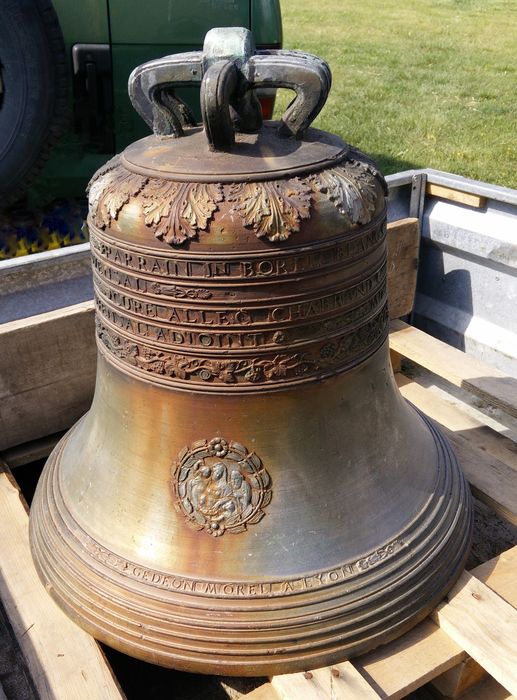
[142,180,223,245]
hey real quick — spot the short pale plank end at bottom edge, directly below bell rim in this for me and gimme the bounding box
[271,661,381,700]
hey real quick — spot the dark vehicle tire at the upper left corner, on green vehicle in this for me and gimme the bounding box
[0,0,67,209]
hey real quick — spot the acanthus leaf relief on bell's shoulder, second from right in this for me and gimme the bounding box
[226,179,311,241]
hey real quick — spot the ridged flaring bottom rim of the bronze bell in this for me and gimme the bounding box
[31,412,473,676]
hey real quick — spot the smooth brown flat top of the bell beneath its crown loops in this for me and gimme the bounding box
[121,121,348,183]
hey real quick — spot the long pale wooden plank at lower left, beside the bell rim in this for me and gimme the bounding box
[0,467,124,700]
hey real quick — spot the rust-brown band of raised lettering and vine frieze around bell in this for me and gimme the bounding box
[92,221,388,391]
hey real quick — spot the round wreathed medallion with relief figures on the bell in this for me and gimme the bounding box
[172,437,272,537]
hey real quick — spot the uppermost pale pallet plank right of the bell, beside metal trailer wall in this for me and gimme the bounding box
[390,320,517,418]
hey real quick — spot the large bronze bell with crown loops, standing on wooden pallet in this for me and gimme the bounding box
[31,28,471,675]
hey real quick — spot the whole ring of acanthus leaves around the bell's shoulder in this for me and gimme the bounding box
[88,151,385,245]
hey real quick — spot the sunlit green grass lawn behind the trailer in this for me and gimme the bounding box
[277,0,517,188]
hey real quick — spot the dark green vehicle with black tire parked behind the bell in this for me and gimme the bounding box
[0,0,282,208]
